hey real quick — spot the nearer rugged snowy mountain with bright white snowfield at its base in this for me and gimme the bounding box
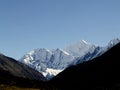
[21,48,74,77]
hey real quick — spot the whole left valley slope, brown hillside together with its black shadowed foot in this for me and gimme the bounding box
[0,54,46,88]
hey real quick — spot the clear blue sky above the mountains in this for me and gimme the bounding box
[0,0,120,59]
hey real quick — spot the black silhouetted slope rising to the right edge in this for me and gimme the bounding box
[49,43,120,90]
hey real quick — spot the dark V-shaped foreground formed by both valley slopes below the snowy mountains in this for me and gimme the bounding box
[0,43,120,90]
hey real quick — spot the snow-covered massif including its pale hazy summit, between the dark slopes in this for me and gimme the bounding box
[21,40,95,78]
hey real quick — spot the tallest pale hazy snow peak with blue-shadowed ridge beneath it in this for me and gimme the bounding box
[64,40,103,66]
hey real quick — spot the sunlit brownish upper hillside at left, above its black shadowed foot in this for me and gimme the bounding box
[0,54,46,81]
